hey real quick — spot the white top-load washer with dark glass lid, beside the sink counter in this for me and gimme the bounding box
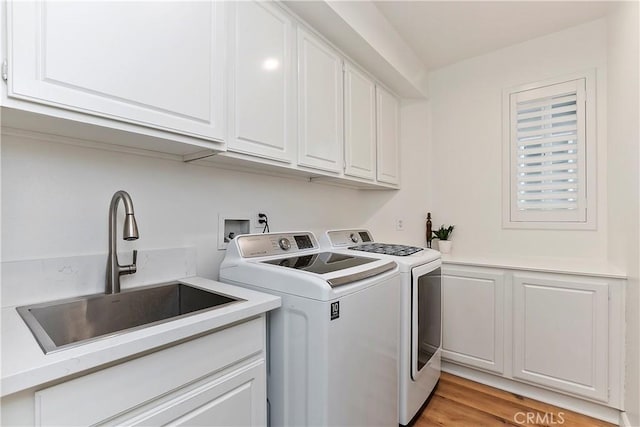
[220,232,400,426]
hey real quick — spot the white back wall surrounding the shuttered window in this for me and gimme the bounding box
[429,20,607,260]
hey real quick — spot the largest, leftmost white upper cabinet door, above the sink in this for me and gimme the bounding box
[7,1,225,141]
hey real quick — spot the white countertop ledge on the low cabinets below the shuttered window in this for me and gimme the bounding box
[442,253,627,279]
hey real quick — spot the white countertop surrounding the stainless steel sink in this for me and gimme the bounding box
[0,277,281,396]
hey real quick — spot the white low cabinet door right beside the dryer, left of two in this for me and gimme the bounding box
[442,268,504,374]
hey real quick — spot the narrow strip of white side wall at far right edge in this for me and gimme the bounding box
[607,2,640,426]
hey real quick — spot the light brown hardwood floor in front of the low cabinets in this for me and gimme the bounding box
[414,372,613,427]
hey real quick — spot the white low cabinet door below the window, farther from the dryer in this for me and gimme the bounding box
[513,274,609,401]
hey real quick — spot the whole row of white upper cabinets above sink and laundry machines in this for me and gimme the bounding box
[5,0,399,189]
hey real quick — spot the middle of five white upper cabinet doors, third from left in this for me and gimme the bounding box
[298,29,343,173]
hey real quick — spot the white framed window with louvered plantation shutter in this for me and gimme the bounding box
[503,73,595,228]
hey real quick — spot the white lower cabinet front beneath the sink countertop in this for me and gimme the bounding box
[2,315,267,426]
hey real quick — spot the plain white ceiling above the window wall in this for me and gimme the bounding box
[375,1,615,70]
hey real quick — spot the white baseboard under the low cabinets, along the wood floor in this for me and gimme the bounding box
[442,361,631,427]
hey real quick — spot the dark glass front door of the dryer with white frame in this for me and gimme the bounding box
[411,260,442,381]
